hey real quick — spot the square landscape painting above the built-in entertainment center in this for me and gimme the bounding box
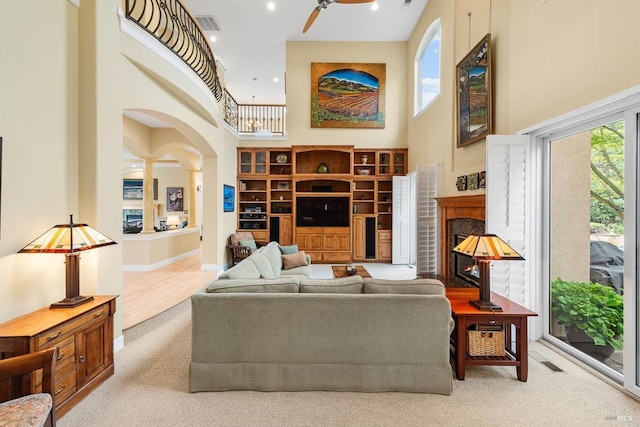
[311,62,387,128]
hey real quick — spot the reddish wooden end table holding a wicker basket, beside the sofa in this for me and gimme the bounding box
[446,288,537,381]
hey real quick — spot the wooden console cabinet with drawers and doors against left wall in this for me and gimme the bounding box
[0,295,116,417]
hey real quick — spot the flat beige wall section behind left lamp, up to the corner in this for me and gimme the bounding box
[0,1,78,321]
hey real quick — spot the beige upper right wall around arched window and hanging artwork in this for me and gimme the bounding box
[407,0,640,196]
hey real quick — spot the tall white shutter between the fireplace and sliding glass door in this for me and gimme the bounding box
[486,135,534,308]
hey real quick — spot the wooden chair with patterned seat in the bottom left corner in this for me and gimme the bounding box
[0,347,58,427]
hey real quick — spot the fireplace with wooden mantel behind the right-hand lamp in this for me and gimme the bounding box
[436,194,485,286]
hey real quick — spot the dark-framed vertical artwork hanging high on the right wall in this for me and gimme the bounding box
[456,34,493,147]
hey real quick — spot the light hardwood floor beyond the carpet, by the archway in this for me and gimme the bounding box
[122,254,217,330]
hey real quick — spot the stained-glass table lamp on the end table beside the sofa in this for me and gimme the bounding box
[453,234,524,311]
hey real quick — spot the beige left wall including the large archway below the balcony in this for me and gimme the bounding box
[0,0,237,337]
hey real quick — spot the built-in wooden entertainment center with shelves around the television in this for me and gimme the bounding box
[238,145,408,263]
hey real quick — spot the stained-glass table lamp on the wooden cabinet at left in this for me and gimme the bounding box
[18,215,116,308]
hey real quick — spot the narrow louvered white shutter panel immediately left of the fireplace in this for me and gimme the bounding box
[414,165,438,275]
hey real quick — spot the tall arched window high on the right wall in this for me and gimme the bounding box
[413,19,440,117]
